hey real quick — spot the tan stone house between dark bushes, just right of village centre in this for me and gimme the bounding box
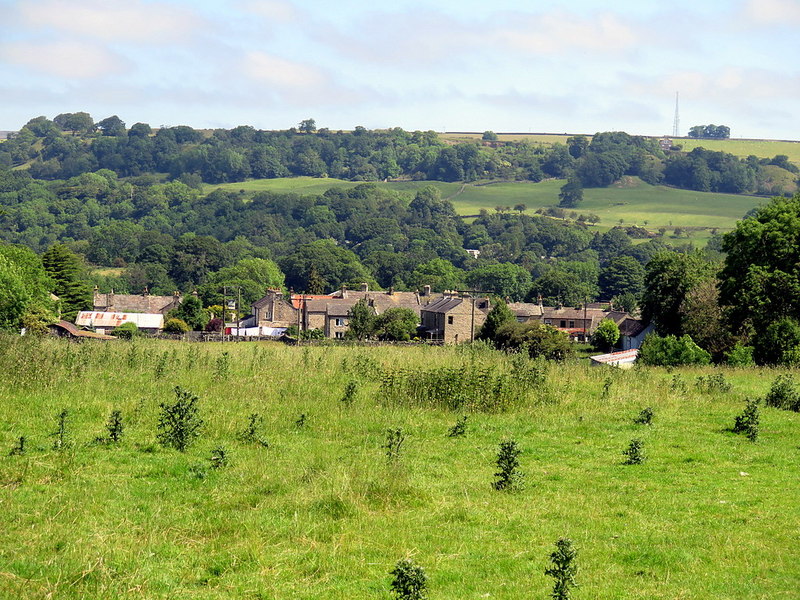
[421,296,490,344]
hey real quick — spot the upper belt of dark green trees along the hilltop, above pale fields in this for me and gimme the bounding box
[0,112,797,197]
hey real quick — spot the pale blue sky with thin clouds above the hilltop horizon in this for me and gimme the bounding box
[0,0,800,140]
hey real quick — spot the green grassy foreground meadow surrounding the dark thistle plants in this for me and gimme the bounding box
[0,337,800,600]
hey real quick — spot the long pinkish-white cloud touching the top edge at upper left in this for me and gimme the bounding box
[18,0,204,44]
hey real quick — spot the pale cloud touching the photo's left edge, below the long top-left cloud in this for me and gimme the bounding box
[0,41,130,79]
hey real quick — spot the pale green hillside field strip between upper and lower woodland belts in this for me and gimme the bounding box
[205,177,766,244]
